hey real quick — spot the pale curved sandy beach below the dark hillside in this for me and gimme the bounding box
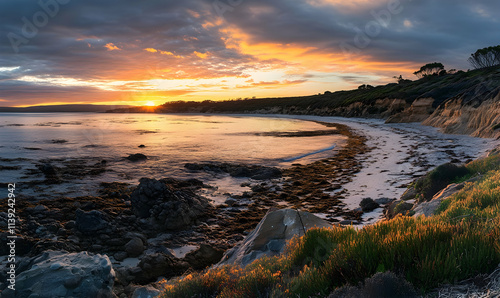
[245,115,500,225]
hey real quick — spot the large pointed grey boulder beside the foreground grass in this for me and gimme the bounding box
[216,209,332,267]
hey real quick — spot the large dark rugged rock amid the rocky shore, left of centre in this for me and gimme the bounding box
[130,178,213,230]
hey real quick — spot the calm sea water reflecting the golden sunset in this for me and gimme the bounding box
[0,113,344,201]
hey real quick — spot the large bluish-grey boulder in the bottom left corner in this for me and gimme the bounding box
[9,251,115,298]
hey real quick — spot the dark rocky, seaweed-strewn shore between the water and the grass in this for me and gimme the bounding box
[0,114,498,297]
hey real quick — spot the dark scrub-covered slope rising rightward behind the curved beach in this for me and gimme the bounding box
[161,67,500,112]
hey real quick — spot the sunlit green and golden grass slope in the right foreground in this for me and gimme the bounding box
[159,154,500,297]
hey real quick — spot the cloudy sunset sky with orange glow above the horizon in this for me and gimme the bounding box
[0,0,500,106]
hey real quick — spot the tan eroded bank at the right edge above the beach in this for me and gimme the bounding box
[422,87,500,138]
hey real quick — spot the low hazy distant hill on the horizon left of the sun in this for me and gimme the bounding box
[0,104,131,113]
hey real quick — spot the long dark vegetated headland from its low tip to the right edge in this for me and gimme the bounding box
[114,66,500,116]
